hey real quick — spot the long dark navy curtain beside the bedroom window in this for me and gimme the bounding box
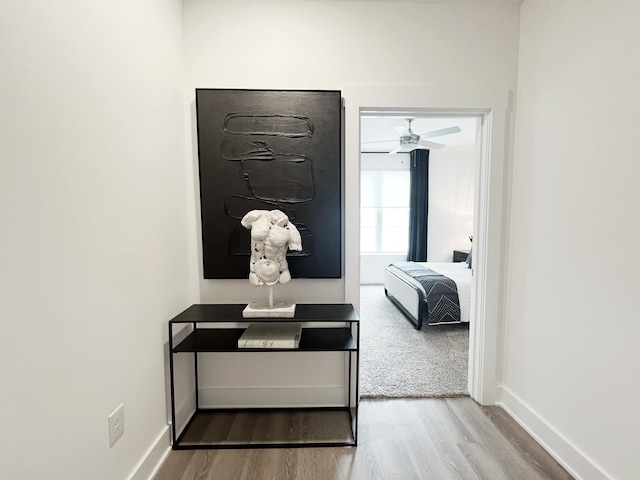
[407,149,429,262]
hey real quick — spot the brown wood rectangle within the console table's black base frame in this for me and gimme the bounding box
[173,407,356,450]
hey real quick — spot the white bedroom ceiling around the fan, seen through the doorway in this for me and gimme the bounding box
[360,114,478,152]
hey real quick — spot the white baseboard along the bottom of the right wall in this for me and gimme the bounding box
[496,386,612,480]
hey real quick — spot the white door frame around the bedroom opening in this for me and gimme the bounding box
[343,85,510,405]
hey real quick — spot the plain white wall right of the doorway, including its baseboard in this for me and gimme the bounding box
[503,0,640,480]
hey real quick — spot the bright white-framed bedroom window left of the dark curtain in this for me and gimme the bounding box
[360,161,410,253]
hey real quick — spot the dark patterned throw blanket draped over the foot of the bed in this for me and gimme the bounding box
[392,262,460,324]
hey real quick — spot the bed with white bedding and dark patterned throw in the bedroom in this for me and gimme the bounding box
[384,262,471,330]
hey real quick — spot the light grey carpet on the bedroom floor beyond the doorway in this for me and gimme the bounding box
[360,285,469,398]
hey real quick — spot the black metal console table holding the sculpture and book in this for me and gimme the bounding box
[169,304,360,450]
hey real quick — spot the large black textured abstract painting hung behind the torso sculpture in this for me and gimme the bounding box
[196,89,342,279]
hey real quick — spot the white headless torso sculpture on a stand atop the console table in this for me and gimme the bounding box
[241,210,302,316]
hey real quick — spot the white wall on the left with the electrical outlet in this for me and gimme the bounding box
[0,0,189,480]
